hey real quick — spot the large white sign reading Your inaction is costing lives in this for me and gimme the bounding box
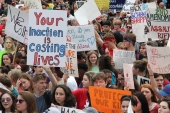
[27,9,67,67]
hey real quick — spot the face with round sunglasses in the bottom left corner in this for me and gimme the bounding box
[1,93,13,109]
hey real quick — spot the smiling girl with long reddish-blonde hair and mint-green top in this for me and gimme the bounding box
[86,51,99,72]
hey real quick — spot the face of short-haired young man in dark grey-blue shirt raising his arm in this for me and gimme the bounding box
[34,80,47,92]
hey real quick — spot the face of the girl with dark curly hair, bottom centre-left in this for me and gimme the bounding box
[55,87,66,106]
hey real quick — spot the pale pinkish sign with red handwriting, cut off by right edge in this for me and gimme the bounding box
[147,46,170,74]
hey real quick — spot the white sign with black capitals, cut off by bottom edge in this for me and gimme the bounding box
[51,104,83,113]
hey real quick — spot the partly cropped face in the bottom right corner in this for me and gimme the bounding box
[158,101,170,113]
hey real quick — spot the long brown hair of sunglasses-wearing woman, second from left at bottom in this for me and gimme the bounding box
[17,91,38,113]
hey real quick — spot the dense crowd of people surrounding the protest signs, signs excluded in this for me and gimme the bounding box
[0,0,170,113]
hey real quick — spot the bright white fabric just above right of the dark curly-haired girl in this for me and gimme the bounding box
[67,76,78,91]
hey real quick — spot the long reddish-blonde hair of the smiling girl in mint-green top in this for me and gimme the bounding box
[86,51,98,71]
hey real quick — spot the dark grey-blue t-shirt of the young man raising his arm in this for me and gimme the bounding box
[34,95,48,113]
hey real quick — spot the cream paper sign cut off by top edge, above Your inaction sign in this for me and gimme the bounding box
[23,0,42,9]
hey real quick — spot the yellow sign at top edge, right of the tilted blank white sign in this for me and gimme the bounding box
[95,0,110,10]
